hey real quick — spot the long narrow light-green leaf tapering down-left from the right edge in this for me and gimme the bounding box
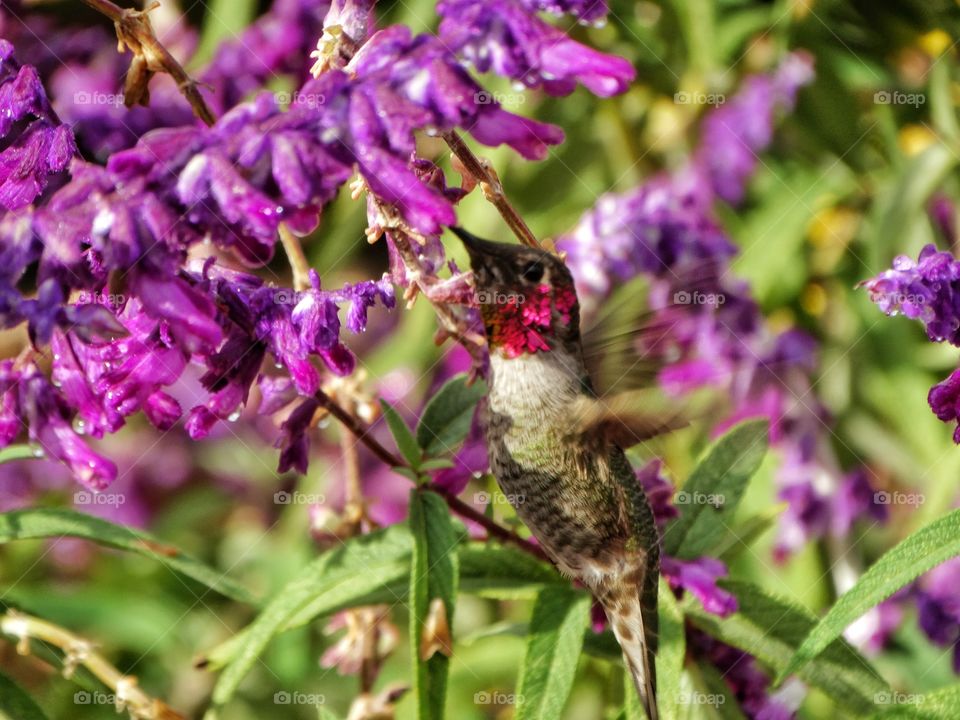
[777,510,960,682]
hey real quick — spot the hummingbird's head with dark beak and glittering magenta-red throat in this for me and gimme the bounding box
[450,227,580,358]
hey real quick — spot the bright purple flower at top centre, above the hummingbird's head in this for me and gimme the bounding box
[437,0,636,97]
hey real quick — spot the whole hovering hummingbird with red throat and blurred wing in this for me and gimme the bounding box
[451,227,670,720]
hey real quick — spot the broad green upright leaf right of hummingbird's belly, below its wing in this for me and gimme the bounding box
[663,420,768,559]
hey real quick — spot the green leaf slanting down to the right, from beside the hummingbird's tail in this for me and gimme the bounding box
[682,580,890,714]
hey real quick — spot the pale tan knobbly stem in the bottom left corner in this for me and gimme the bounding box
[0,610,186,720]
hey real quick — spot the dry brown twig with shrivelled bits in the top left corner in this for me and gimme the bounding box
[83,0,216,125]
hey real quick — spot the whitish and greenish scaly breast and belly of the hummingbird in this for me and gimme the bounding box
[481,350,632,577]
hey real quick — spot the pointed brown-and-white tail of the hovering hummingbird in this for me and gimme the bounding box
[597,565,659,720]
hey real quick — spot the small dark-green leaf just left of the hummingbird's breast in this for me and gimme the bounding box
[417,374,487,455]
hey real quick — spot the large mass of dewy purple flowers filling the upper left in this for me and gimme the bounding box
[0,0,633,488]
